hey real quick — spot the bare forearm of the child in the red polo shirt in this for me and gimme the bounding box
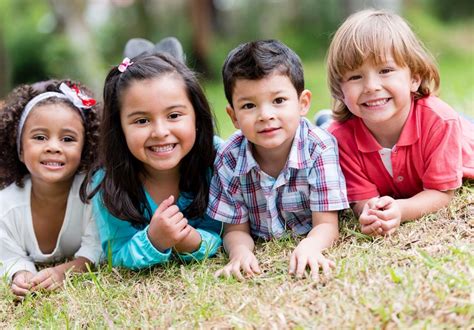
[397,190,454,222]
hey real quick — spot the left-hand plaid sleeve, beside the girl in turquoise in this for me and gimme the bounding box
[207,154,248,224]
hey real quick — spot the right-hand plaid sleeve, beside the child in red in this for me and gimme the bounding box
[308,136,349,212]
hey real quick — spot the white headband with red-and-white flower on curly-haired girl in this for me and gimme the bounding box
[16,83,96,156]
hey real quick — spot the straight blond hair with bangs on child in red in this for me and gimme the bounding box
[327,9,439,121]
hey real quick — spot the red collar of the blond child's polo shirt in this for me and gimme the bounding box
[356,99,420,152]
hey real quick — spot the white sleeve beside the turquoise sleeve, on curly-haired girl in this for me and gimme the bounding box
[74,204,102,264]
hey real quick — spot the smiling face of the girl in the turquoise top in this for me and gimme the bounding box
[120,74,196,178]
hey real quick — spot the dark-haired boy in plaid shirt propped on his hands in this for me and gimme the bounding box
[207,40,348,280]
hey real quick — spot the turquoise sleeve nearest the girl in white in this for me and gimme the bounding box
[93,194,171,269]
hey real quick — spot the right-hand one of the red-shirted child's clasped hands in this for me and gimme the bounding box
[368,196,402,235]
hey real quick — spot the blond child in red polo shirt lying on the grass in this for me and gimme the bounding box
[328,10,474,235]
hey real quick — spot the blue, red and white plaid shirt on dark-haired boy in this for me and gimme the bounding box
[207,118,349,239]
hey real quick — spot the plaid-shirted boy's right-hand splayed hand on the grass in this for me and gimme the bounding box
[289,237,335,281]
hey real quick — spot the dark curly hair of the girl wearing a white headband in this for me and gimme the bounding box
[0,80,99,190]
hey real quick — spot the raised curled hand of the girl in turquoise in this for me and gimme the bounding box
[148,196,192,251]
